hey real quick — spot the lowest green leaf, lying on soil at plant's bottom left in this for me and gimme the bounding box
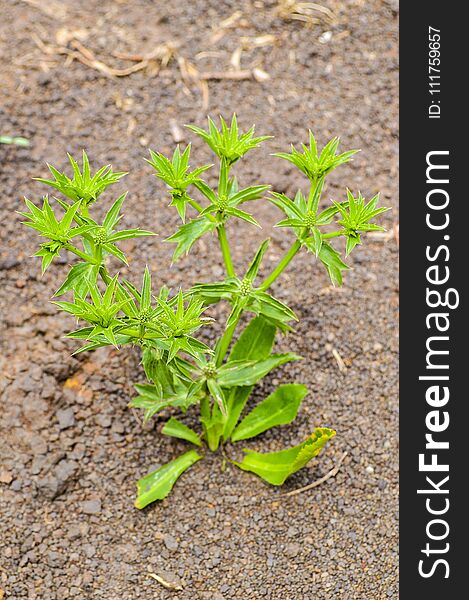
[135,450,202,509]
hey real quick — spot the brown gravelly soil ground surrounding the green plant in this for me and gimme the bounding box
[0,0,398,600]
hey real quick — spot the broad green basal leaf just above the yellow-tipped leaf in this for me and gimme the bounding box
[231,383,308,442]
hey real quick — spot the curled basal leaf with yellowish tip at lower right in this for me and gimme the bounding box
[235,427,336,485]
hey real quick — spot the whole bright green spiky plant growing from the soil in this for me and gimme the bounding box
[21,116,387,508]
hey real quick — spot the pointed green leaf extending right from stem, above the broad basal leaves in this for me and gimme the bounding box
[217,352,301,387]
